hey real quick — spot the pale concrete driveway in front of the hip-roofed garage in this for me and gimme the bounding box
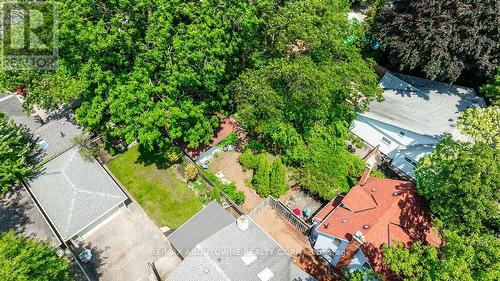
[80,202,180,281]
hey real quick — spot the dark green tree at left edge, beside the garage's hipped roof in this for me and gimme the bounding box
[0,112,39,195]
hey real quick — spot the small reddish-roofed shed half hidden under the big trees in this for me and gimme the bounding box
[181,116,236,165]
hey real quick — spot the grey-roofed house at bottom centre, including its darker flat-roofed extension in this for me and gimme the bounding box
[167,202,315,281]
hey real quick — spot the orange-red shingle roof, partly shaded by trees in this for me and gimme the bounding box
[314,178,442,276]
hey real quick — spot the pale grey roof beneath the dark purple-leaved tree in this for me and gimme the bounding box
[362,71,485,137]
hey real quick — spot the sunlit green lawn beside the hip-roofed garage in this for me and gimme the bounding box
[109,146,202,229]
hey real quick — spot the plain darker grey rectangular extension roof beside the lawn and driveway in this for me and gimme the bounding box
[168,201,234,257]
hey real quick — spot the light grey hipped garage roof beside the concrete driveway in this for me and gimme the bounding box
[29,148,127,240]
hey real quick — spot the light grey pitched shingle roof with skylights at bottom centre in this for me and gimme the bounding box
[167,204,314,281]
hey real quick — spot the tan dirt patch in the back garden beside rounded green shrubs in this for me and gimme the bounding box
[209,151,263,212]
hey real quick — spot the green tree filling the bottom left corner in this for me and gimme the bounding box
[0,231,69,281]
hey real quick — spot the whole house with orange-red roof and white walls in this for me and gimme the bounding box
[310,165,442,279]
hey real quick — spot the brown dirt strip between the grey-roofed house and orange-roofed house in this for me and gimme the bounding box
[253,206,339,281]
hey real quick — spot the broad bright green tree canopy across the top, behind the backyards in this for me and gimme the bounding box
[0,0,381,199]
